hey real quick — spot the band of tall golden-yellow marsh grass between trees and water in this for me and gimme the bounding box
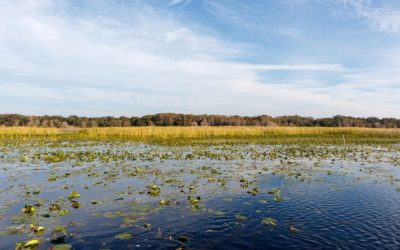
[0,126,400,145]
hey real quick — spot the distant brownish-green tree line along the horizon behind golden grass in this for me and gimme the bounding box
[0,113,400,128]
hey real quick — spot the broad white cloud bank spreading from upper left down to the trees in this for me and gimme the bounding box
[0,1,399,116]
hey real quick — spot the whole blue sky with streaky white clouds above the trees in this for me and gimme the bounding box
[0,0,400,118]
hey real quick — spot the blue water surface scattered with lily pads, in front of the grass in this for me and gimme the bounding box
[0,144,400,249]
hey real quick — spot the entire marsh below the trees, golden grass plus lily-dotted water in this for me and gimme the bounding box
[0,127,400,249]
